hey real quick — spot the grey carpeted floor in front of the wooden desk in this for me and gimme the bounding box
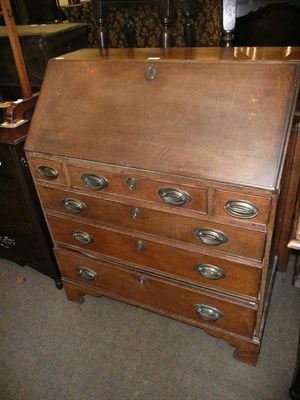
[0,255,300,400]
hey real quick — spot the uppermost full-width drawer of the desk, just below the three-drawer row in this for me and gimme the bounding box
[39,187,265,260]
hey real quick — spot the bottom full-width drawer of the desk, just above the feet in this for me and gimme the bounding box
[55,249,256,337]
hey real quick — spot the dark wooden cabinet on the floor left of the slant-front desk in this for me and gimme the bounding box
[0,122,62,288]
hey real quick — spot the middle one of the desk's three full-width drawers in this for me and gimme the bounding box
[48,216,261,299]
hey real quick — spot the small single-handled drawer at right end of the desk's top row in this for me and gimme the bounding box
[215,190,271,224]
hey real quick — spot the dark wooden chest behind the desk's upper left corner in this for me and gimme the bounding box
[0,23,87,99]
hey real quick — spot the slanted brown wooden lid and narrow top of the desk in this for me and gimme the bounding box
[25,48,299,190]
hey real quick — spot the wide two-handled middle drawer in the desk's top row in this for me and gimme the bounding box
[68,165,207,214]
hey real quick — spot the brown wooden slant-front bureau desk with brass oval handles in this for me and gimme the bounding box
[25,47,299,364]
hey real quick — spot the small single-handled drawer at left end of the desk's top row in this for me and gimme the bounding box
[28,157,66,185]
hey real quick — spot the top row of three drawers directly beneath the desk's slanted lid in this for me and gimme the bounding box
[30,158,271,225]
